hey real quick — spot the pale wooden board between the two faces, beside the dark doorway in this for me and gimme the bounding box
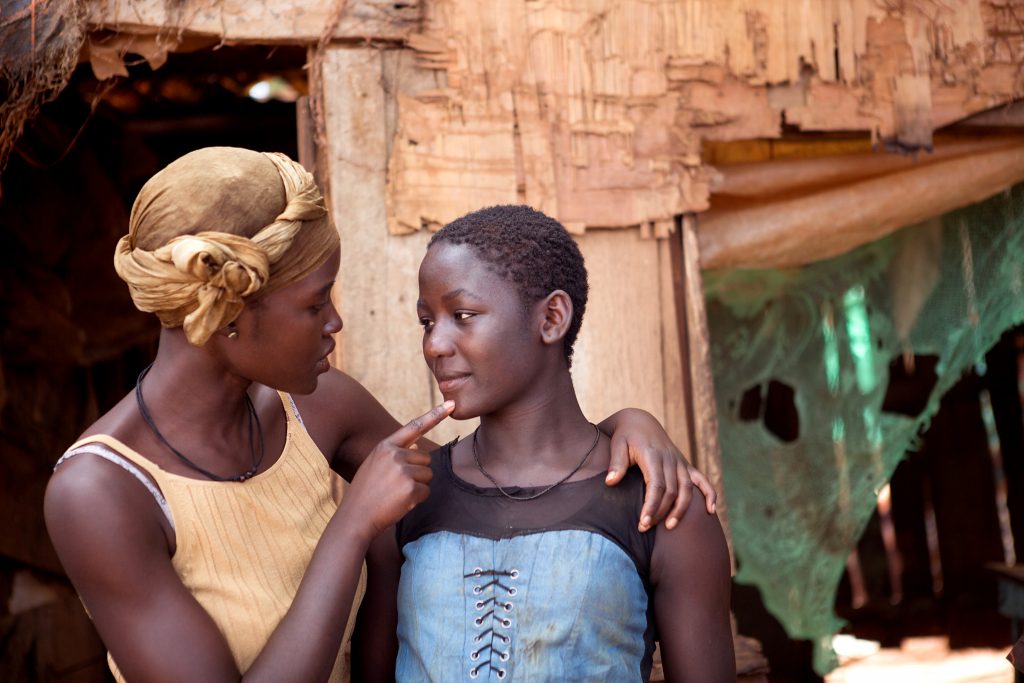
[324,47,471,441]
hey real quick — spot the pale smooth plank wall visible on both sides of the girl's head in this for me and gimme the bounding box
[324,47,688,443]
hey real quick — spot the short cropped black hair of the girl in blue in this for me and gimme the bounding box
[427,205,589,366]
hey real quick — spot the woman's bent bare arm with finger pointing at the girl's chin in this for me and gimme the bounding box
[45,409,451,681]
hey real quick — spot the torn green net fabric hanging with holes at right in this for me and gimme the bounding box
[705,185,1024,674]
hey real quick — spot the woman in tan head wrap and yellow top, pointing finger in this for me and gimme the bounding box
[39,147,714,681]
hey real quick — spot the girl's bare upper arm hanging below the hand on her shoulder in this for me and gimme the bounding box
[650,489,736,683]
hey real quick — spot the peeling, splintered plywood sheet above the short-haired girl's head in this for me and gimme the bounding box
[388,0,1024,237]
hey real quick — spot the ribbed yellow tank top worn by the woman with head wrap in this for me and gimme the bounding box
[68,394,366,683]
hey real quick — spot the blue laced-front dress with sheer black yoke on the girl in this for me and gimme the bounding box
[396,444,654,683]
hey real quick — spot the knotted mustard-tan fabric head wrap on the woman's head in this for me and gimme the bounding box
[114,147,338,346]
